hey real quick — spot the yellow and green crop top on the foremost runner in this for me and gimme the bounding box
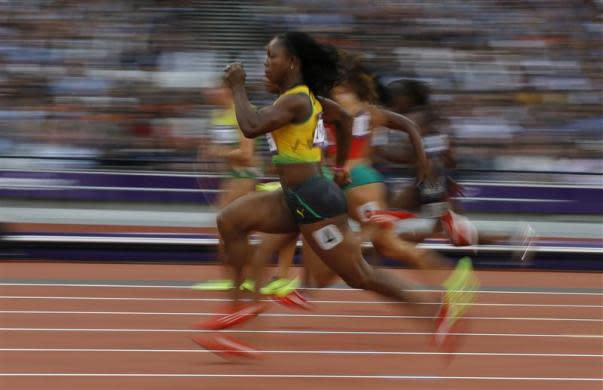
[266,85,326,164]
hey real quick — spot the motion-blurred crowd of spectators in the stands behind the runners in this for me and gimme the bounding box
[0,0,603,177]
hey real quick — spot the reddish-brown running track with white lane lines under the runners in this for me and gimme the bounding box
[0,262,603,390]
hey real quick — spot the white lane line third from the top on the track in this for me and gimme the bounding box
[0,310,603,322]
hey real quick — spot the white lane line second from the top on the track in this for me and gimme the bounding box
[0,295,603,308]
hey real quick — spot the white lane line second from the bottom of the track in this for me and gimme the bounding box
[0,348,603,358]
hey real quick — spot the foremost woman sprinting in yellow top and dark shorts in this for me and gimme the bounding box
[194,32,460,355]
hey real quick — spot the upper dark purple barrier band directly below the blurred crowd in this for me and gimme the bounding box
[0,170,603,215]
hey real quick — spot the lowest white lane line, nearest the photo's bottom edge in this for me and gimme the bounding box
[0,372,603,382]
